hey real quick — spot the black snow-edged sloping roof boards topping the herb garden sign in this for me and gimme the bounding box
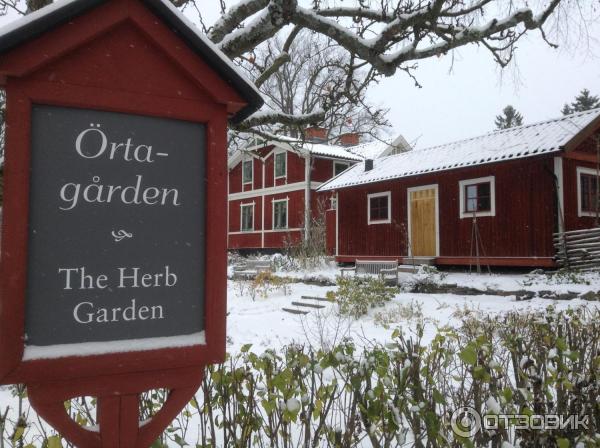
[0,0,264,123]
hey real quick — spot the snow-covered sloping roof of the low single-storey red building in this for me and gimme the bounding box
[319,108,600,191]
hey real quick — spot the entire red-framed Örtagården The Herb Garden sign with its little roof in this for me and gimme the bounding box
[0,0,262,448]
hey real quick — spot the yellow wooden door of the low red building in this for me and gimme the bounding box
[409,188,437,257]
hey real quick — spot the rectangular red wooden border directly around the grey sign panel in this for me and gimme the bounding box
[0,80,227,383]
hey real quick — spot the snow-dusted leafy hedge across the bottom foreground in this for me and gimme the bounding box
[2,302,600,448]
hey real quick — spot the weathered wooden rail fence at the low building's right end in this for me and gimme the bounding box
[554,227,600,270]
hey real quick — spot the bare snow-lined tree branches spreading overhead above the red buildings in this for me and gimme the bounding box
[0,0,580,138]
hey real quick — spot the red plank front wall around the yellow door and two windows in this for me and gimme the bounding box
[338,157,557,264]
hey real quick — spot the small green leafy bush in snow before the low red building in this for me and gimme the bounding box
[328,276,397,318]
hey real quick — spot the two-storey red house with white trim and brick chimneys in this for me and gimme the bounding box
[228,133,407,252]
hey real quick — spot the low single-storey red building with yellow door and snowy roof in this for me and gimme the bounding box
[319,109,600,267]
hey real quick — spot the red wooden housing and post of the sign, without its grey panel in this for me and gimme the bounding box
[0,0,262,442]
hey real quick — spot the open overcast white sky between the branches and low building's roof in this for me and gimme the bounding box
[0,0,600,147]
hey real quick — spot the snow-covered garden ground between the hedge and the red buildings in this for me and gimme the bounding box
[0,264,600,446]
